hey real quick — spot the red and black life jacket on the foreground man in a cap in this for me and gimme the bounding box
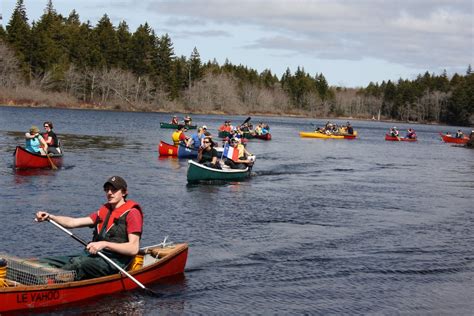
[93,200,143,243]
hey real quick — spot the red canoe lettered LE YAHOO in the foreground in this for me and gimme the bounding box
[0,244,188,313]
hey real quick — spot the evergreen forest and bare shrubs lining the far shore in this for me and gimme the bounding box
[0,0,474,125]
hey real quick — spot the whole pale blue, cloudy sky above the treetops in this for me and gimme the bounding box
[0,0,474,87]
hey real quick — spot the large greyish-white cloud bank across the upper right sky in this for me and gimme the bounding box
[148,0,474,68]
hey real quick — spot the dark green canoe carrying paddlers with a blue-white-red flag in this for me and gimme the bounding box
[187,160,250,182]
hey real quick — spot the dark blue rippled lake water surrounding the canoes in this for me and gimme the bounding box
[0,107,474,315]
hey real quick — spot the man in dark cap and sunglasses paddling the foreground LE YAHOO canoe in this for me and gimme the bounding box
[35,176,143,280]
